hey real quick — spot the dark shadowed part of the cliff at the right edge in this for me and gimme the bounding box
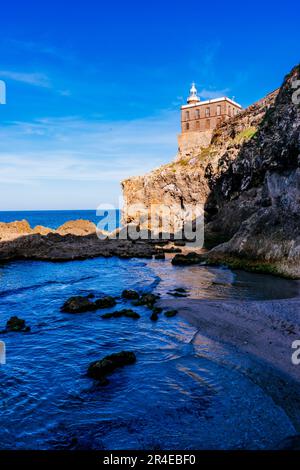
[205,65,300,256]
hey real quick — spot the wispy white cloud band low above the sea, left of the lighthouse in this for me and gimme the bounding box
[0,111,179,210]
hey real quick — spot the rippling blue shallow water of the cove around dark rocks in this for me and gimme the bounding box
[0,258,299,449]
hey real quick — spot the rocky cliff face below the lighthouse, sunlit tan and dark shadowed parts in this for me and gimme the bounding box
[122,66,300,277]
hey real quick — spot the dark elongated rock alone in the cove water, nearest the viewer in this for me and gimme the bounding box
[87,351,136,385]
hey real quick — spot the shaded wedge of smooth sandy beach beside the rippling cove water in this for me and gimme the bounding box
[161,298,300,382]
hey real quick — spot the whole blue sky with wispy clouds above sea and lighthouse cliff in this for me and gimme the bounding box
[0,0,300,210]
